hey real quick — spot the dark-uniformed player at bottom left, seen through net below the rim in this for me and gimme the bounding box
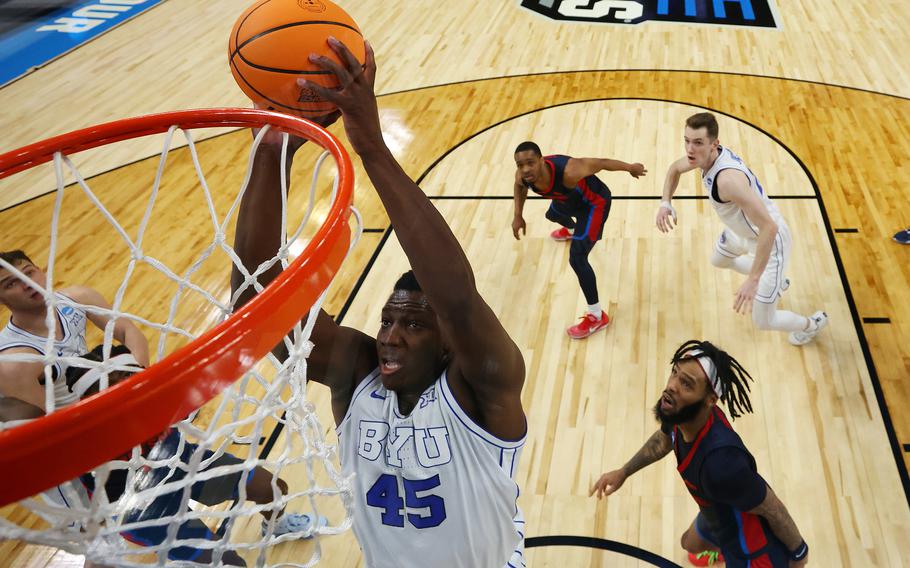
[0,345,327,568]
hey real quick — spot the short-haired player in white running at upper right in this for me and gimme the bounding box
[657,112,828,345]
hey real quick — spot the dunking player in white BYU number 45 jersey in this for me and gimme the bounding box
[235,42,527,568]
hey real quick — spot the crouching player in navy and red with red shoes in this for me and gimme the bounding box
[512,141,647,339]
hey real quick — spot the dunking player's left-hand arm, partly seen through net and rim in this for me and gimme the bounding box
[231,129,376,418]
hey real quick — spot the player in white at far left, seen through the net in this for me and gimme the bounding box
[0,250,149,410]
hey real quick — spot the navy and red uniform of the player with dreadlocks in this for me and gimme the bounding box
[670,406,790,568]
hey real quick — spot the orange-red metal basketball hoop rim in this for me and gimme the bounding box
[0,108,354,506]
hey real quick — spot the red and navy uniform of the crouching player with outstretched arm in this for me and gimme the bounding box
[525,154,610,243]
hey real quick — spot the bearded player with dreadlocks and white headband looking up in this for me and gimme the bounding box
[590,340,809,568]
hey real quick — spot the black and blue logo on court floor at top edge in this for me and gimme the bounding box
[521,0,777,28]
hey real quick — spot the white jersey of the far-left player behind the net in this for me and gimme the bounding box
[0,292,88,408]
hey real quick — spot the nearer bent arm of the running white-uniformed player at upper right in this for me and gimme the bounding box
[714,170,778,313]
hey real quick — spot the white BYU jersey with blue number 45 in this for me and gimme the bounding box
[336,370,525,568]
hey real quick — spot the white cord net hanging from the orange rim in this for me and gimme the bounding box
[0,122,362,566]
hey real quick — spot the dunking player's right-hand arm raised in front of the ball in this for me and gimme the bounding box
[301,39,525,439]
